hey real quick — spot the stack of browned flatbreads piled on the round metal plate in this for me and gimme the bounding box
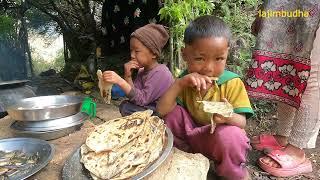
[80,110,165,180]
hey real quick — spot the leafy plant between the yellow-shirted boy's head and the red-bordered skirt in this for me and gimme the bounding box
[214,0,261,77]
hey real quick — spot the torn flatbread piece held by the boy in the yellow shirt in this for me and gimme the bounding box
[198,101,233,134]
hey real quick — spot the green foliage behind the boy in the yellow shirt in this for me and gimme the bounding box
[159,0,275,122]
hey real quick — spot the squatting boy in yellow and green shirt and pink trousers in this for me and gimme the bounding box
[157,16,253,180]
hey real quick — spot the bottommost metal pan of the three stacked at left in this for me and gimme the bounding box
[12,121,83,140]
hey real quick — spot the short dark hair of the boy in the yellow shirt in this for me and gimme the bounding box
[183,15,232,45]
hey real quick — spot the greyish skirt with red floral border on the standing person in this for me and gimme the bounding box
[245,0,320,108]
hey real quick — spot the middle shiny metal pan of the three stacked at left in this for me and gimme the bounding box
[11,112,88,131]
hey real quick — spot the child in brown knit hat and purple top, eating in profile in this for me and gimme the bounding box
[103,24,173,116]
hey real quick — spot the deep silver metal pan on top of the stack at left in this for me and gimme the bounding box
[7,95,83,121]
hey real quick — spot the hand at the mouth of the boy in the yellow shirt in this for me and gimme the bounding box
[181,73,212,91]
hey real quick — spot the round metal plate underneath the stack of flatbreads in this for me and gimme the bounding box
[62,128,173,180]
